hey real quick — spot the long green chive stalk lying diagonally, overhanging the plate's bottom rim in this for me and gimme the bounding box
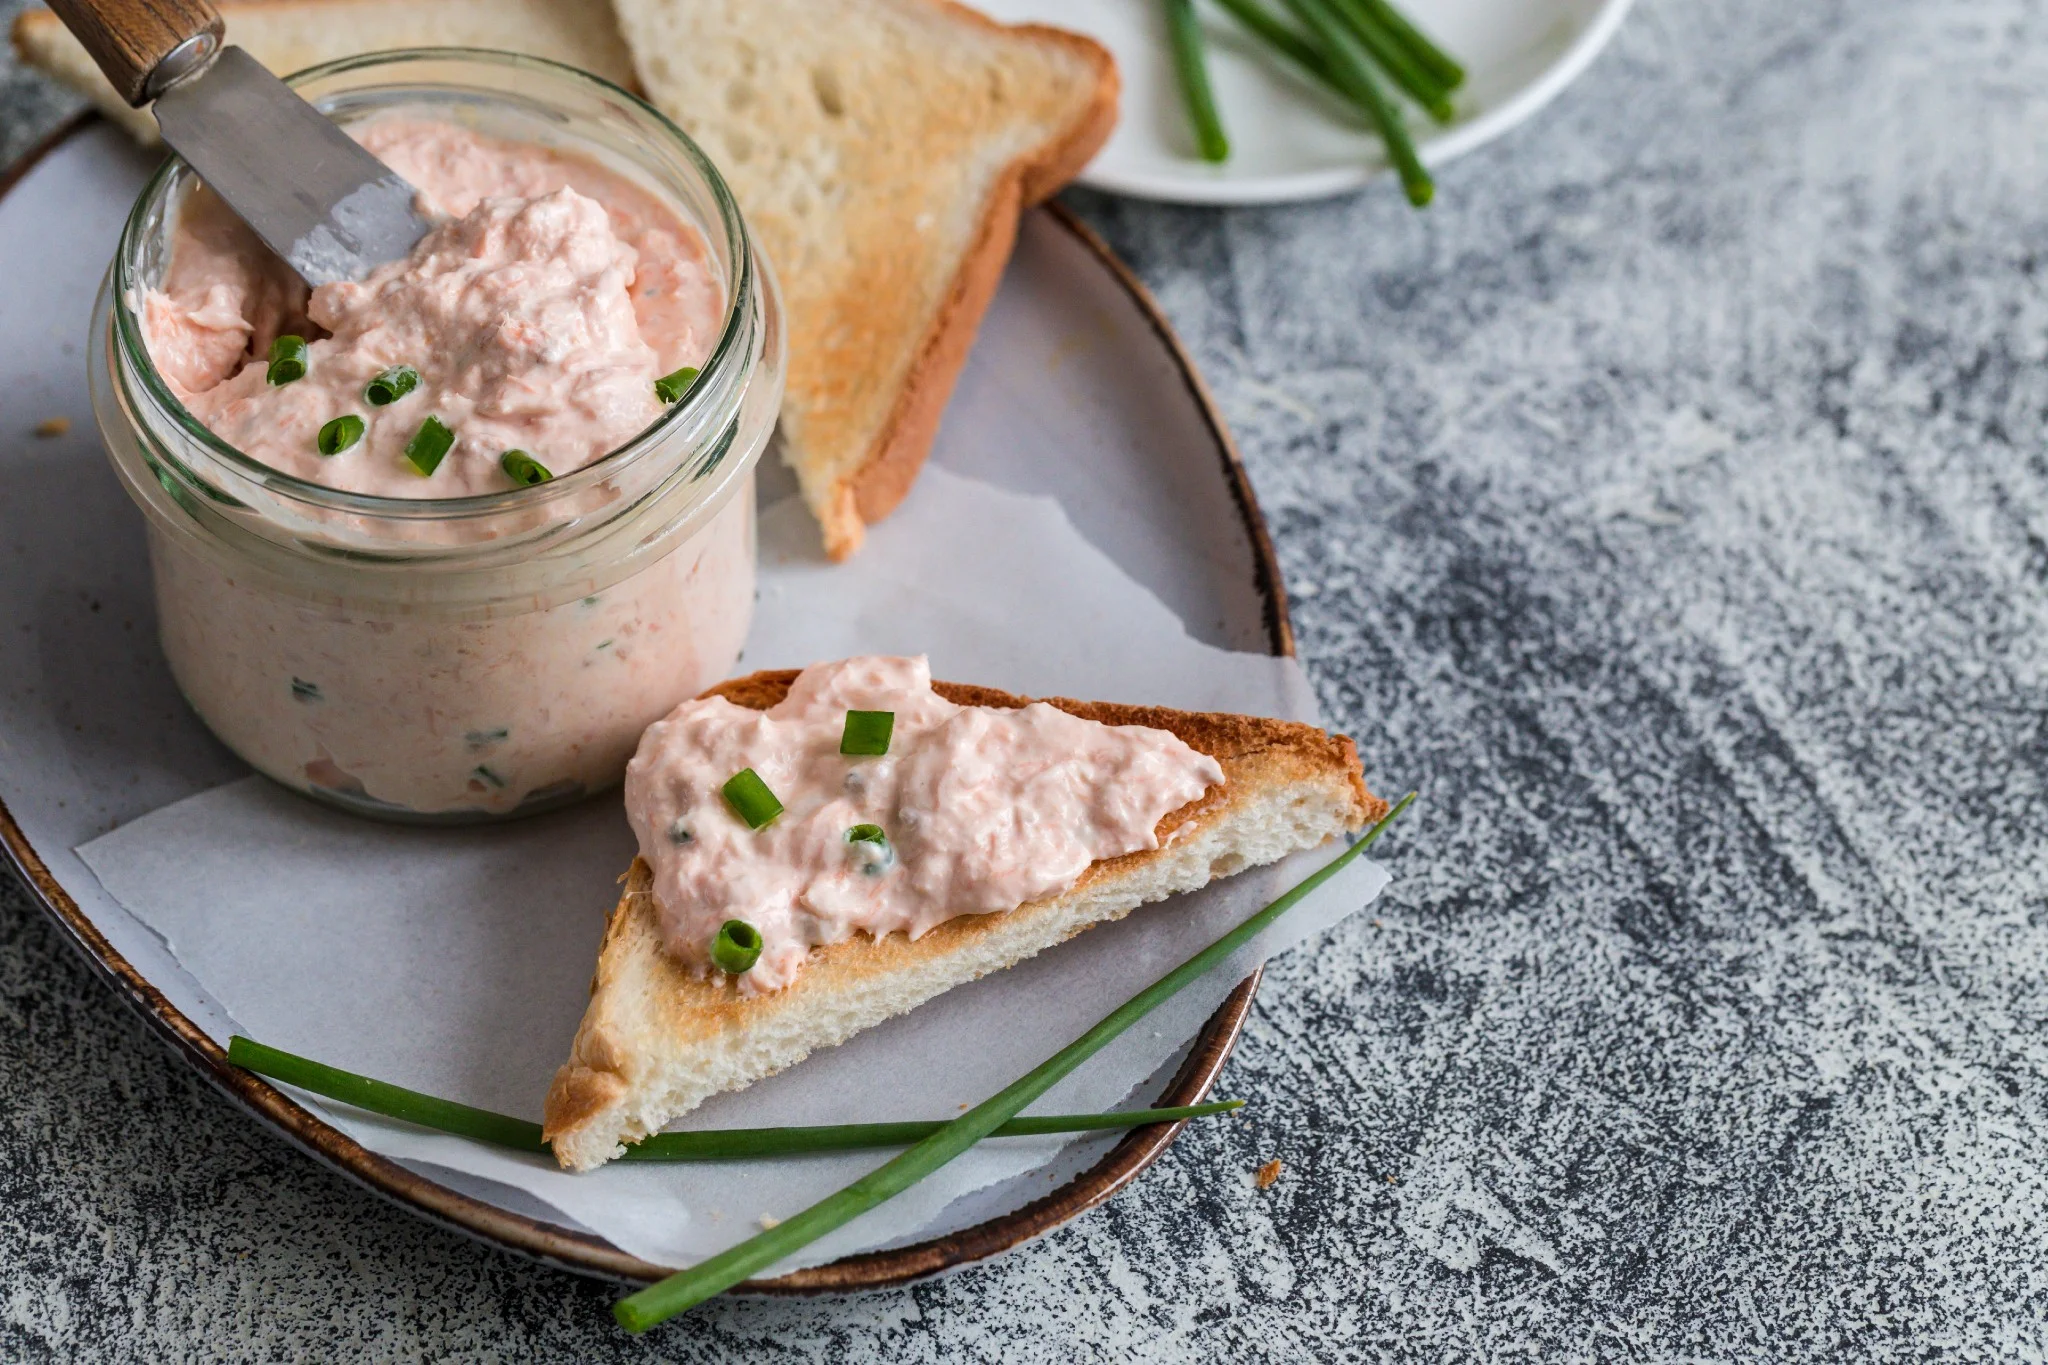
[612,792,1415,1332]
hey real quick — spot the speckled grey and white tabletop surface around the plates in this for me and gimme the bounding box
[0,0,2048,1361]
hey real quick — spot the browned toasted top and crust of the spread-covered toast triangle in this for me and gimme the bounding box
[543,671,1386,1169]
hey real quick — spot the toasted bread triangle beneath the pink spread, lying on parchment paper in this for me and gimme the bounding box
[543,671,1386,1171]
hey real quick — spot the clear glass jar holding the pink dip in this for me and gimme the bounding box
[90,49,784,823]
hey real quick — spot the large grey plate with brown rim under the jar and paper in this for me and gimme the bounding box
[0,119,1292,1293]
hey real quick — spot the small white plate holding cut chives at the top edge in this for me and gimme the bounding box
[981,0,1630,205]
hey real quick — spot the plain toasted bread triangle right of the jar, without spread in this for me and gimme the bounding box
[614,0,1118,559]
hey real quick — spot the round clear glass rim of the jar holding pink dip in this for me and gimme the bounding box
[111,47,758,520]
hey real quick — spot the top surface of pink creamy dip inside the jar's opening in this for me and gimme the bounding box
[139,119,725,497]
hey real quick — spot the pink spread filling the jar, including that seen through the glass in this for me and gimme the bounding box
[100,93,784,821]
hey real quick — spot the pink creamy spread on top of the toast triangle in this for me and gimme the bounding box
[627,657,1223,995]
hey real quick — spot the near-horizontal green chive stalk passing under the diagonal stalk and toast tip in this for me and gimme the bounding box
[227,1033,1245,1160]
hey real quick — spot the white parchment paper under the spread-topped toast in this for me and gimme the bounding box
[78,469,1386,1269]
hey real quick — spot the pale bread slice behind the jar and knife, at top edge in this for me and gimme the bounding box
[14,0,633,141]
